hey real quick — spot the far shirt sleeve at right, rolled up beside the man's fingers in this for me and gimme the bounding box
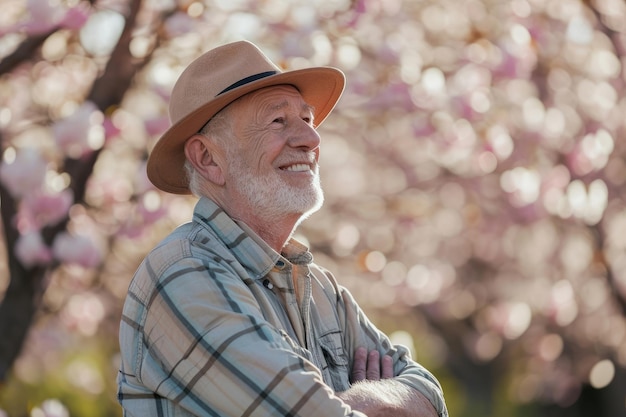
[324,271,448,417]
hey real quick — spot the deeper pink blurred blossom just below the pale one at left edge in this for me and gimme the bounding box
[22,189,74,228]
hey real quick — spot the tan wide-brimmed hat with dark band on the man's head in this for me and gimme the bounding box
[147,41,345,194]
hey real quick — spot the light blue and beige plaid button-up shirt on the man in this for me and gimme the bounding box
[118,198,447,417]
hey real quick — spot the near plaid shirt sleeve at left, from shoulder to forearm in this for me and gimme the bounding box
[124,254,365,417]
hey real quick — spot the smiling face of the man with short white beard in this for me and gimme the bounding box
[221,86,323,221]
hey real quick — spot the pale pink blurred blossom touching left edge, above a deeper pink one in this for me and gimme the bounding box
[0,148,47,197]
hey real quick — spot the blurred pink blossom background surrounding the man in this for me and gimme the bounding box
[0,0,626,417]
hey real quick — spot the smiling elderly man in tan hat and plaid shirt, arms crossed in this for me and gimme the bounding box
[118,41,448,417]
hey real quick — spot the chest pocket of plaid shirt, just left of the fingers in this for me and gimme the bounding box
[317,332,350,392]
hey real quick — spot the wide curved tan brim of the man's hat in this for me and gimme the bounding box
[146,67,345,194]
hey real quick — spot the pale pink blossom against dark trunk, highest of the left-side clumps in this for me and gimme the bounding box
[53,101,98,157]
